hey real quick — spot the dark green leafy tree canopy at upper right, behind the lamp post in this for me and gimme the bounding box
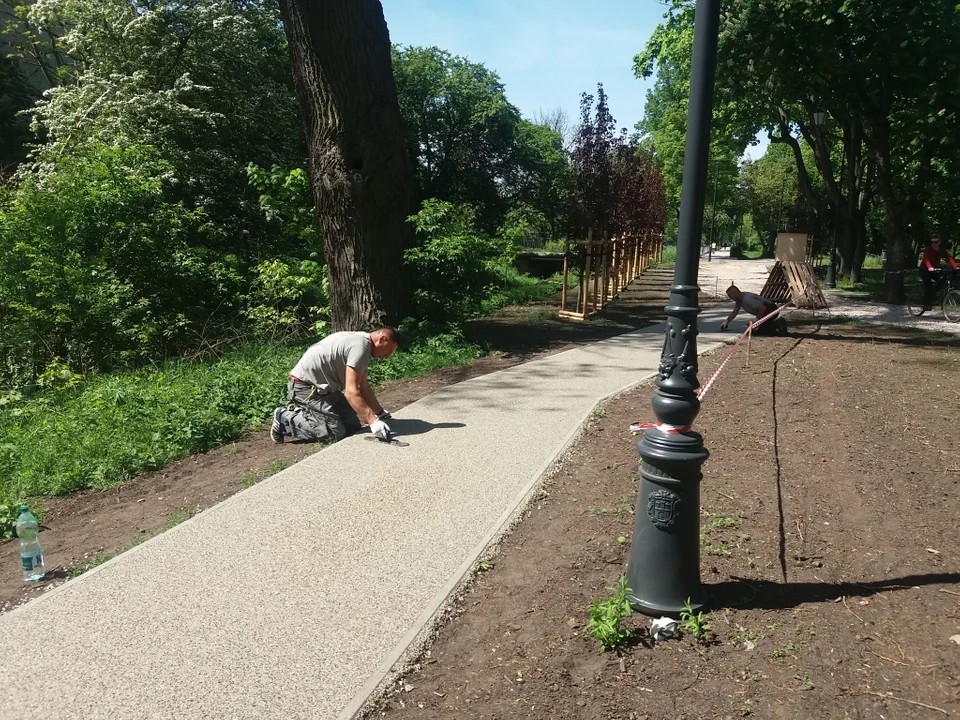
[635,0,960,300]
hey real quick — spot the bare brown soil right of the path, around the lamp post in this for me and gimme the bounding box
[382,324,960,720]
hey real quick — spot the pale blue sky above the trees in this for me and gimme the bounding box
[381,0,766,157]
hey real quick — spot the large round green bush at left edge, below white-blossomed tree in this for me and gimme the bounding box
[0,145,241,386]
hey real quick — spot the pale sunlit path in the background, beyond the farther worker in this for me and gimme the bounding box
[699,250,960,335]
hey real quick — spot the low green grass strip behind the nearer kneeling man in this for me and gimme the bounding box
[0,333,482,503]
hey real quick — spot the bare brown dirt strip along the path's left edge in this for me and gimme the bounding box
[0,269,710,612]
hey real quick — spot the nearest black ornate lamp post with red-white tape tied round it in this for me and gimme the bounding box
[626,0,720,617]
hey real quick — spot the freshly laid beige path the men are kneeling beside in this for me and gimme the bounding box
[0,309,732,720]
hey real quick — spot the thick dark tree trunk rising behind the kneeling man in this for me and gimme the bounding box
[280,0,415,331]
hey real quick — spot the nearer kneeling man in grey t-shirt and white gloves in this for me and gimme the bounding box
[270,328,397,443]
